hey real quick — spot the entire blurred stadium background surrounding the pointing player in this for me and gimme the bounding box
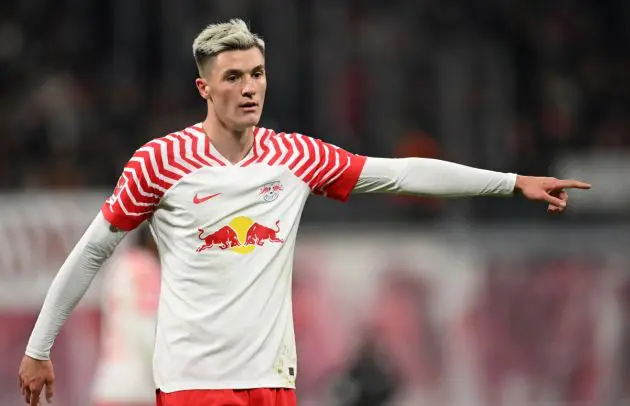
[0,0,630,406]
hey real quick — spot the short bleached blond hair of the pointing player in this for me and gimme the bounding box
[193,18,265,73]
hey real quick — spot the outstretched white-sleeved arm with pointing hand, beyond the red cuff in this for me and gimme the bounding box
[353,157,590,211]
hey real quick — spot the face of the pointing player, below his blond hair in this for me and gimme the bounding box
[195,47,267,131]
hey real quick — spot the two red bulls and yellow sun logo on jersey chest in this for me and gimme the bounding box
[197,216,284,254]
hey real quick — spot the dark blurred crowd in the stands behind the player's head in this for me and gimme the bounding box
[0,0,630,221]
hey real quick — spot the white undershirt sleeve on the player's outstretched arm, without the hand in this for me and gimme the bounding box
[353,157,516,197]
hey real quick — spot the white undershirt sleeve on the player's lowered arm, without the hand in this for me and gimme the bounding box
[26,213,125,360]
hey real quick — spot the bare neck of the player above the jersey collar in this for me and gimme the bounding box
[203,113,254,164]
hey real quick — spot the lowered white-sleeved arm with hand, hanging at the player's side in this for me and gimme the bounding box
[19,212,126,406]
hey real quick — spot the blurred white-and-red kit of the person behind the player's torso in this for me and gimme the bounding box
[93,248,160,404]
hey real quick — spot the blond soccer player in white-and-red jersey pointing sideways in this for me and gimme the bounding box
[19,20,589,406]
